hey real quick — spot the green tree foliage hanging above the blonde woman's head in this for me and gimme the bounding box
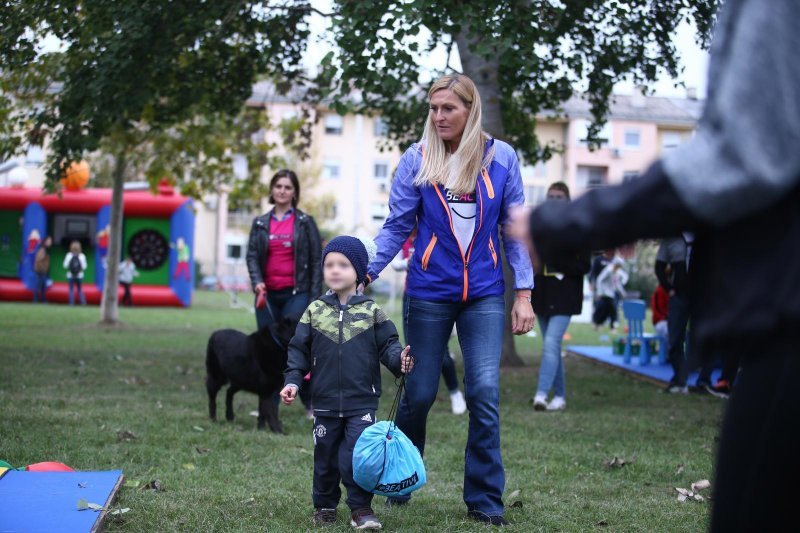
[315,0,719,162]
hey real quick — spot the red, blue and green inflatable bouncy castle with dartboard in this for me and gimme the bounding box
[0,182,194,307]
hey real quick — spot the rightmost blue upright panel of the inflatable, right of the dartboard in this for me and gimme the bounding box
[169,200,194,307]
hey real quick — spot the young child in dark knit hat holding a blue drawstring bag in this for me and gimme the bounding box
[281,236,414,529]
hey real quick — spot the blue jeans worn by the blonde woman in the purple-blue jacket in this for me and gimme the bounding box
[397,296,506,515]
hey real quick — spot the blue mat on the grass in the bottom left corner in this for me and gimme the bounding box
[0,470,123,533]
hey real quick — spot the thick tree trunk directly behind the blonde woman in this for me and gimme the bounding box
[454,28,525,366]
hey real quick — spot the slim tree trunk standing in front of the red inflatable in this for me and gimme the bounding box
[100,151,127,325]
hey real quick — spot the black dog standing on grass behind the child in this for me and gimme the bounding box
[206,316,299,433]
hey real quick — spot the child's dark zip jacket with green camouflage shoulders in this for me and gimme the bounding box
[285,294,402,416]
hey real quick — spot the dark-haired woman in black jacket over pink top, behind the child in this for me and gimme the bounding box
[247,169,322,329]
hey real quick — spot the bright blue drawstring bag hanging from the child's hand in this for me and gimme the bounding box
[353,376,427,497]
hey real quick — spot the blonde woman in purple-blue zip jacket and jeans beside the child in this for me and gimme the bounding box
[368,75,534,525]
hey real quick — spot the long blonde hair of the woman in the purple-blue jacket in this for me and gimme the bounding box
[414,74,494,194]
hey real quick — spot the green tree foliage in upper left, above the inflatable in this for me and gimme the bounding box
[0,0,308,188]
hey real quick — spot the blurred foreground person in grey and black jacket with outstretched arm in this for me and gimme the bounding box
[515,0,800,531]
